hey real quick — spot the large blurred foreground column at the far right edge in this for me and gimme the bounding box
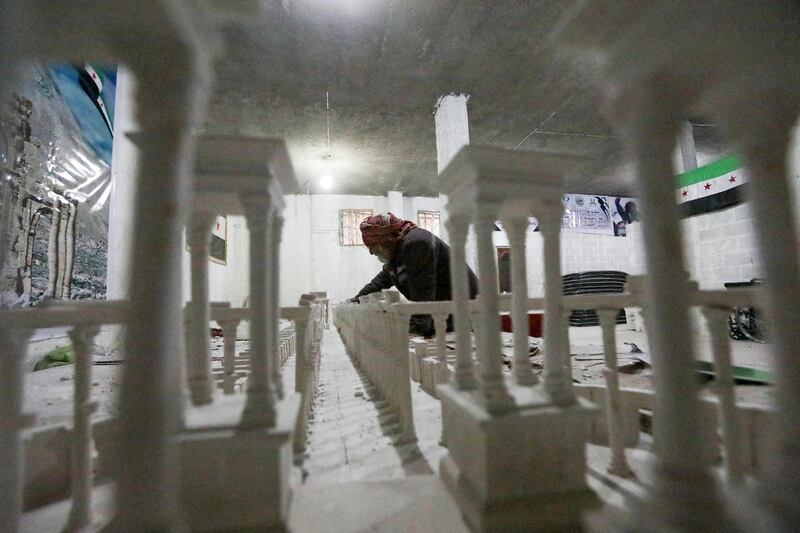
[731,114,800,512]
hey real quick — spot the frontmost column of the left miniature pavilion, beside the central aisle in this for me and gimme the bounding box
[240,194,275,429]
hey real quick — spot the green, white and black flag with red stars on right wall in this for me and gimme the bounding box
[675,156,748,217]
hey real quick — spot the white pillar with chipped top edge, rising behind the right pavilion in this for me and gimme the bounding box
[434,93,469,242]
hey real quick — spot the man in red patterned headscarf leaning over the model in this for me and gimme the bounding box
[352,213,478,337]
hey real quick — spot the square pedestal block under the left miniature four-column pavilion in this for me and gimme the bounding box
[178,394,301,531]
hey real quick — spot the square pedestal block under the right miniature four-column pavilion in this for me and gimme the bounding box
[438,380,599,531]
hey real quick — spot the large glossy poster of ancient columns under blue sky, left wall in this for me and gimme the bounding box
[0,64,116,307]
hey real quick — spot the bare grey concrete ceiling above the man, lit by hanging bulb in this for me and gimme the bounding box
[207,0,728,196]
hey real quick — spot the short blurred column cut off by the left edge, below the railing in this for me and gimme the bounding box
[0,324,33,533]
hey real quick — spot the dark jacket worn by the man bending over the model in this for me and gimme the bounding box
[356,228,478,336]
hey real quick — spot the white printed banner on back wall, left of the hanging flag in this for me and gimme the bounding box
[561,194,639,237]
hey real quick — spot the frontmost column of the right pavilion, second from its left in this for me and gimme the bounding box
[475,202,514,413]
